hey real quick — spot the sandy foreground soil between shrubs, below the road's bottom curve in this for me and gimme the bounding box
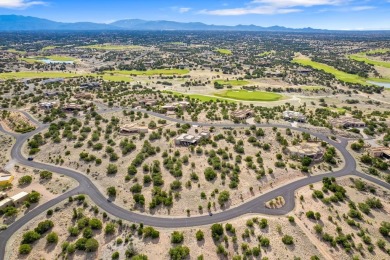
[6,197,322,259]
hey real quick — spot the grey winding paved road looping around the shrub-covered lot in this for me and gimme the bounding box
[0,108,390,259]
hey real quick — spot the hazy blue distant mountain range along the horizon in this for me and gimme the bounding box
[0,15,386,32]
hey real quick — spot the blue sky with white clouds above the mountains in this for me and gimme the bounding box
[0,0,390,30]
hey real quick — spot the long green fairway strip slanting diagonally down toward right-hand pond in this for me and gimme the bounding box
[293,58,369,85]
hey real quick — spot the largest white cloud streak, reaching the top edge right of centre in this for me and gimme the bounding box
[200,0,350,16]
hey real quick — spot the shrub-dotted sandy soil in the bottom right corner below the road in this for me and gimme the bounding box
[294,177,390,259]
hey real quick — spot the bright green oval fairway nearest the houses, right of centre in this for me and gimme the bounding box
[215,90,283,101]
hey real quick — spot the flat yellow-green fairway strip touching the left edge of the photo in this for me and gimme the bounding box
[0,71,88,80]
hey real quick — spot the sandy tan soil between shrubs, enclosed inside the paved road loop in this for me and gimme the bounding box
[26,110,342,216]
